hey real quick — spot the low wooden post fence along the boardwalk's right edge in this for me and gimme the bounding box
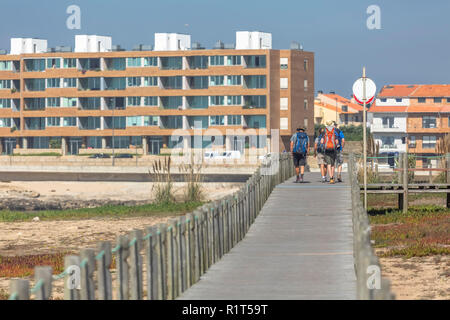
[348,154,395,300]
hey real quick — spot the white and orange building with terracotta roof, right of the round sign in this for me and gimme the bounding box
[370,85,450,167]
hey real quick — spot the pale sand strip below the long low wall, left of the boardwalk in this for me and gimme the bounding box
[0,181,240,201]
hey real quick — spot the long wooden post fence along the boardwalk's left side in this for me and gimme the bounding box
[10,154,294,300]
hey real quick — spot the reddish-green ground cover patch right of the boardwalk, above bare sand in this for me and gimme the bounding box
[368,206,450,258]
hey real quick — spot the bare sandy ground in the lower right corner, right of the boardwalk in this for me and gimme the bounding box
[380,252,450,300]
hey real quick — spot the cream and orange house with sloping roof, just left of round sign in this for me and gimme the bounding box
[314,91,363,125]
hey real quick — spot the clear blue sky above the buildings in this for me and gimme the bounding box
[0,0,450,96]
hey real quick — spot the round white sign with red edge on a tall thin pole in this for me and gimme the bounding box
[353,67,377,210]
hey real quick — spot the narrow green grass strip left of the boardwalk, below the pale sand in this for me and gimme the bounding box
[0,202,202,222]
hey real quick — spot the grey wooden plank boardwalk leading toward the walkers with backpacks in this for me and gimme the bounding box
[180,173,356,300]
